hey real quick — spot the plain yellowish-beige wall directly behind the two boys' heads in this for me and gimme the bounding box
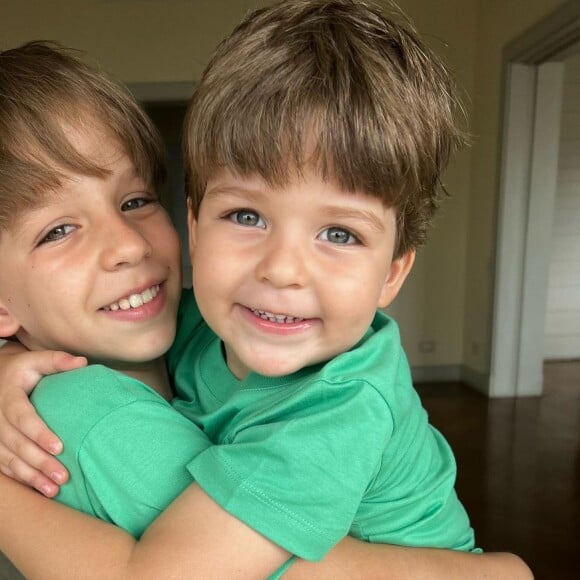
[0,0,476,379]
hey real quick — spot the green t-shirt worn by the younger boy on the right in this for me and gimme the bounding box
[168,293,474,560]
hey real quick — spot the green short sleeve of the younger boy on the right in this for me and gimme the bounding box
[188,381,392,560]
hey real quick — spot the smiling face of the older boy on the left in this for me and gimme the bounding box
[0,128,181,367]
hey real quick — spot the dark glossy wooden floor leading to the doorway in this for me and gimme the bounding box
[0,362,580,580]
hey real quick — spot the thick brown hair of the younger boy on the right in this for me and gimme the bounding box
[184,0,463,256]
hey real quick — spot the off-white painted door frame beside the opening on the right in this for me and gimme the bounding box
[489,0,580,397]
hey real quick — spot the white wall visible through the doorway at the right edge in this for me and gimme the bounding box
[544,55,580,360]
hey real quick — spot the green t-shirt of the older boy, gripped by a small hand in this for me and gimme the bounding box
[31,365,210,538]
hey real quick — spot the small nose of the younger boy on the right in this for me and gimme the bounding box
[256,234,308,288]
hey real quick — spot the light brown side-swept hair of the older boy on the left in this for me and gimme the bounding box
[0,41,165,231]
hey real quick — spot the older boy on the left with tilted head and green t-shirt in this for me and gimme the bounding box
[0,42,215,536]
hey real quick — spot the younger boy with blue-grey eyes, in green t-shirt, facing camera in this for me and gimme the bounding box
[0,1,532,577]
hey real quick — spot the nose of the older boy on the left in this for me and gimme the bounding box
[100,215,153,270]
